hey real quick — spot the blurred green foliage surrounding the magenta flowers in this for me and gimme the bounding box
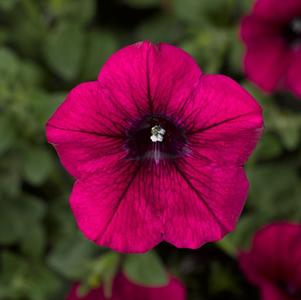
[0,0,301,300]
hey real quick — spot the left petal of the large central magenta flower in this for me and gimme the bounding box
[46,82,126,177]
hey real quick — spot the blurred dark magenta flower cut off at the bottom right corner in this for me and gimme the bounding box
[239,223,301,300]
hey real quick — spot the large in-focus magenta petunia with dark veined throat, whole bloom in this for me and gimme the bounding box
[47,42,263,252]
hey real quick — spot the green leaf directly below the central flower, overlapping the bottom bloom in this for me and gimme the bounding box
[123,251,168,286]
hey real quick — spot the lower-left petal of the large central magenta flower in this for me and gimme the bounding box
[70,160,164,253]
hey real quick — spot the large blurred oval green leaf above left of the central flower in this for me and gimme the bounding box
[44,23,84,81]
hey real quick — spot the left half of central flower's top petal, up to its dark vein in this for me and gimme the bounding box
[98,42,153,119]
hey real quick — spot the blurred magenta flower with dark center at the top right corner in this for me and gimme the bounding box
[241,0,301,97]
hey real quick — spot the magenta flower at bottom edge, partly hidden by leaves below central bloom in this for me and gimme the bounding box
[66,273,186,300]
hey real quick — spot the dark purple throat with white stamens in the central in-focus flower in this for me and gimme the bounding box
[127,115,186,163]
